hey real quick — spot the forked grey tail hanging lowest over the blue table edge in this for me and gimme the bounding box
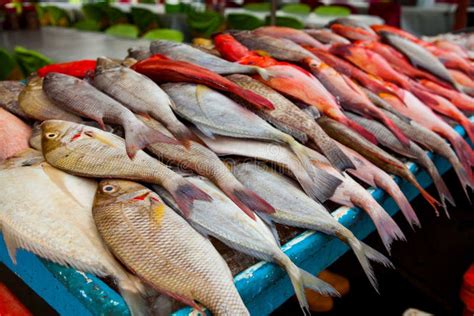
[282,256,340,315]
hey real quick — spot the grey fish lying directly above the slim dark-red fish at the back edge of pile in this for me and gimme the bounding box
[150,40,261,75]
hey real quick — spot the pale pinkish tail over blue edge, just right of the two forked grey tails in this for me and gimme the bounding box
[351,196,406,253]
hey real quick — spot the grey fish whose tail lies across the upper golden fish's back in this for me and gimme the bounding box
[43,73,177,158]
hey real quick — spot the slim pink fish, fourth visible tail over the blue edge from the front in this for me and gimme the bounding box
[339,144,421,228]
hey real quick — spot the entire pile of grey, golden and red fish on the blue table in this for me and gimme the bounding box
[0,19,474,315]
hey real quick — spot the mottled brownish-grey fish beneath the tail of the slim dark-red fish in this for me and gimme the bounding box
[227,74,354,171]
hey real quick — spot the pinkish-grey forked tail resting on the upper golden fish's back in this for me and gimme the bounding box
[124,122,180,158]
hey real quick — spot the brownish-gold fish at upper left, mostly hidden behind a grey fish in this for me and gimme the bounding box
[18,77,82,123]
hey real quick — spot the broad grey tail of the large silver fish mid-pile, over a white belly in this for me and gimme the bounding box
[290,139,342,203]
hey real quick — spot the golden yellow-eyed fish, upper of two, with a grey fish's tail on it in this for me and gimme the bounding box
[41,120,210,218]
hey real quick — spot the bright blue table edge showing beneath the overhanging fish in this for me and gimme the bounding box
[0,116,474,316]
